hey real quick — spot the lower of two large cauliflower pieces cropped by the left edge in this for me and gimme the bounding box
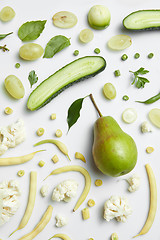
[0,180,21,225]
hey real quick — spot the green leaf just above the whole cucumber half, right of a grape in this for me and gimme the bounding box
[43,35,71,58]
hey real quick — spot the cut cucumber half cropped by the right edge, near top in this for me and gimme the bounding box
[123,10,160,30]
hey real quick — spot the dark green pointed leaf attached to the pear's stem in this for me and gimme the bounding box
[67,98,84,131]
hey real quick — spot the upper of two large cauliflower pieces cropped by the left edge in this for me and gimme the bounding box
[0,119,25,155]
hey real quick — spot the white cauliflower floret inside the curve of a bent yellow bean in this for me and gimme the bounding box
[52,180,78,202]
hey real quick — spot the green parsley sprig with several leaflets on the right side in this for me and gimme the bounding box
[129,67,149,88]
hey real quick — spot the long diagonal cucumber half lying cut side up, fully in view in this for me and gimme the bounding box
[27,56,106,111]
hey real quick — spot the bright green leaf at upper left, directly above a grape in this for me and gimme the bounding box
[18,20,47,42]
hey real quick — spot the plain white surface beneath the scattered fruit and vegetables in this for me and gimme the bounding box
[0,0,160,240]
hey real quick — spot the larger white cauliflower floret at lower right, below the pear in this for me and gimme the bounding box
[104,196,132,222]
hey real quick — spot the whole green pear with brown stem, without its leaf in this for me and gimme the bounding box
[90,95,137,177]
